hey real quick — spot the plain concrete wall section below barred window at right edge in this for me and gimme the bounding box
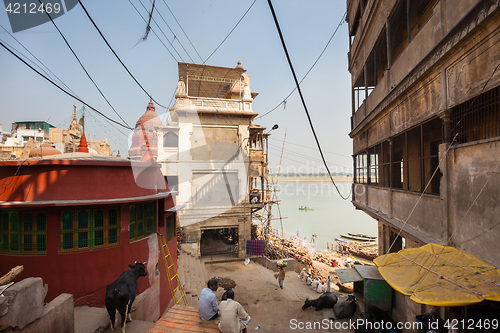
[448,139,500,268]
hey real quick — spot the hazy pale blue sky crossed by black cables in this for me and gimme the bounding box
[0,0,352,173]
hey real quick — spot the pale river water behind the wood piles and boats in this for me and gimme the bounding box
[271,180,378,251]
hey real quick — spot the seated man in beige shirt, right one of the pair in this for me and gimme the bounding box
[219,289,251,333]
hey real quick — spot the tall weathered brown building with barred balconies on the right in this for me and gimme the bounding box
[347,0,500,321]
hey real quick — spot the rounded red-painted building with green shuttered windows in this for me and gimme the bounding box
[0,149,177,320]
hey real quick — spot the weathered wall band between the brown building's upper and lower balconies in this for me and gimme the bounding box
[351,0,500,140]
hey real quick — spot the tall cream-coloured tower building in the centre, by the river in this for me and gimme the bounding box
[156,63,269,257]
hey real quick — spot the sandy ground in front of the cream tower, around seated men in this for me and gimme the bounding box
[206,261,358,333]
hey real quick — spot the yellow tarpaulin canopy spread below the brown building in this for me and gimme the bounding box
[373,244,500,306]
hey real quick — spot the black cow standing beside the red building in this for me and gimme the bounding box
[105,261,148,332]
